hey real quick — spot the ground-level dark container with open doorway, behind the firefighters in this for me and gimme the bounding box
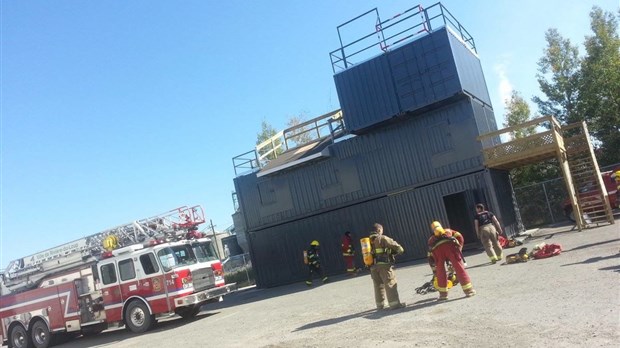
[249,170,517,287]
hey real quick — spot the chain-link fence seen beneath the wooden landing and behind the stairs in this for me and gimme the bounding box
[514,164,620,229]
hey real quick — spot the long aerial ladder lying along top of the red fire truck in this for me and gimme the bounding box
[2,206,205,291]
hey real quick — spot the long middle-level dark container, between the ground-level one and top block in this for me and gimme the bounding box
[234,96,495,231]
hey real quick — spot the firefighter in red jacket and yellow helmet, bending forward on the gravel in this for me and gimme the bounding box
[428,221,476,301]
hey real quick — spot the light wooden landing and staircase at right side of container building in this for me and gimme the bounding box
[478,116,614,230]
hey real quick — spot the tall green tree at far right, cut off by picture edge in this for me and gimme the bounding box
[579,6,620,165]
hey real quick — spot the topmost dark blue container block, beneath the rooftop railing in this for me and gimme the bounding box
[334,27,491,134]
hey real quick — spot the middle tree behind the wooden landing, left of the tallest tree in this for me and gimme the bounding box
[533,28,581,124]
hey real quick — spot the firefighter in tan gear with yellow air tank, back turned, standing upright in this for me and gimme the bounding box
[370,223,405,309]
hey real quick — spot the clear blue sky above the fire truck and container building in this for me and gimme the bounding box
[0,0,618,267]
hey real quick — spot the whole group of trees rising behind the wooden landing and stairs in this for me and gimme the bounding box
[504,6,620,187]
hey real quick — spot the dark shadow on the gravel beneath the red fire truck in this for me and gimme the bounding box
[56,312,219,348]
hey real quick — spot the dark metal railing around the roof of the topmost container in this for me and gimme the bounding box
[329,2,477,74]
